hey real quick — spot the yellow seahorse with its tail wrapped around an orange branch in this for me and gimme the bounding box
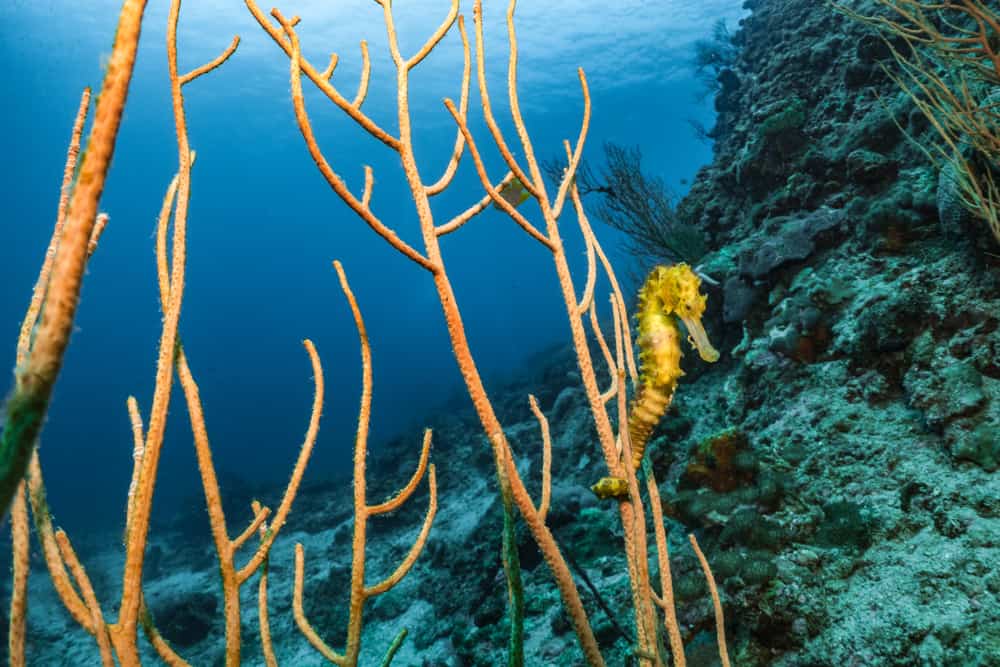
[591,263,719,499]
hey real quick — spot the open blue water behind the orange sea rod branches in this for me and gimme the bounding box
[0,0,741,531]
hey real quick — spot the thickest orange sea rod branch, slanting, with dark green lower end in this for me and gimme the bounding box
[0,0,146,515]
